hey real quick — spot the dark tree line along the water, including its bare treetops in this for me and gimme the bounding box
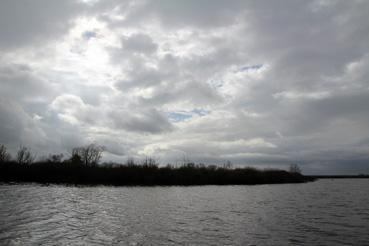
[0,144,313,186]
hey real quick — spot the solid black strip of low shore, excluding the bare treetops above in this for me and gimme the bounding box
[0,162,315,186]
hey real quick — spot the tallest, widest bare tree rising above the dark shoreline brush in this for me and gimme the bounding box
[72,144,104,166]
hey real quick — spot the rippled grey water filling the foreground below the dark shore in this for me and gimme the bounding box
[0,179,369,245]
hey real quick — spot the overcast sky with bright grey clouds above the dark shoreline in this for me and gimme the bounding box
[0,0,369,174]
